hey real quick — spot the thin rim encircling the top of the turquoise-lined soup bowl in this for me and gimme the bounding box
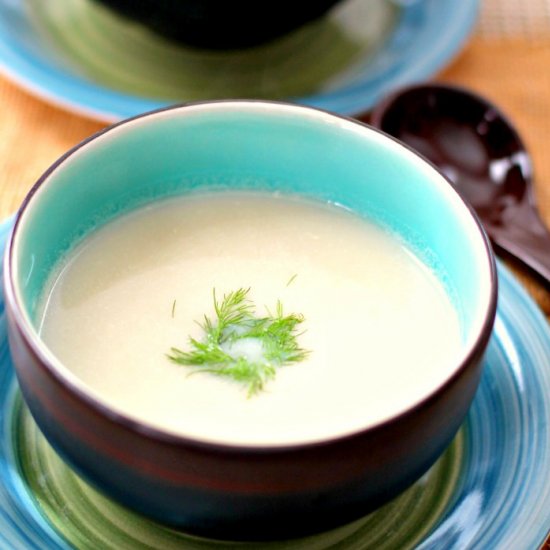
[4,99,498,455]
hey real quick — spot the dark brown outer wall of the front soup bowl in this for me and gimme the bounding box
[7,296,494,540]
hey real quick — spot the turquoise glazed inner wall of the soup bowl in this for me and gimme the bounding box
[12,102,494,365]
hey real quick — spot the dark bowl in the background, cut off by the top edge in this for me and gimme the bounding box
[95,0,339,49]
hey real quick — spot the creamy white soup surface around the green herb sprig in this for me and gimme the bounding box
[36,192,461,445]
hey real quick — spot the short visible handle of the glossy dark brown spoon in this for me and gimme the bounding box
[487,213,550,287]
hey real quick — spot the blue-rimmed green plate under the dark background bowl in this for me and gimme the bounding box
[0,0,479,121]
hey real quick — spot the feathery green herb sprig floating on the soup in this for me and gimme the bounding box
[168,288,309,397]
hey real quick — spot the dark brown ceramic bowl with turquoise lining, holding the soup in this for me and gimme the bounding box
[4,101,497,540]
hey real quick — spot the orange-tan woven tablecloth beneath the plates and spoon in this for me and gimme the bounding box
[0,0,550,549]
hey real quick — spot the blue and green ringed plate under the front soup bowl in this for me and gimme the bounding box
[0,218,550,550]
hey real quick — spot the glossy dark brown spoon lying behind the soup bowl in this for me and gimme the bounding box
[364,84,550,285]
